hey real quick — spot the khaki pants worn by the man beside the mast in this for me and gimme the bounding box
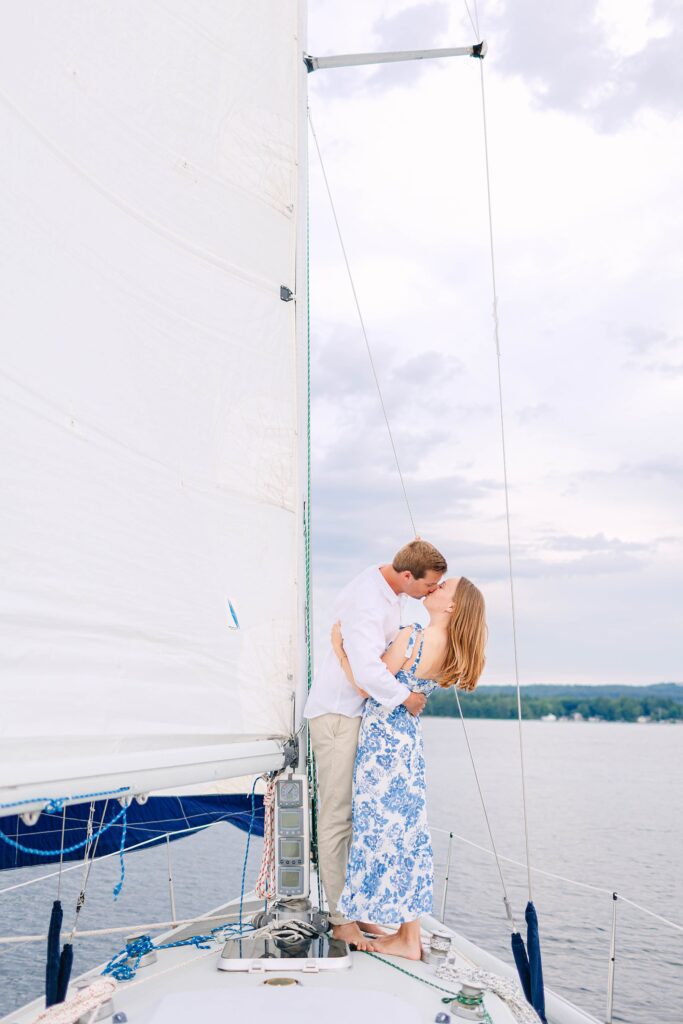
[308,715,360,925]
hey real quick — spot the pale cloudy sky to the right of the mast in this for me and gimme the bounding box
[308,0,683,683]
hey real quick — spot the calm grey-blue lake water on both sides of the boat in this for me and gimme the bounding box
[0,718,683,1024]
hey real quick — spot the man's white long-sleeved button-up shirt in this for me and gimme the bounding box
[304,565,411,718]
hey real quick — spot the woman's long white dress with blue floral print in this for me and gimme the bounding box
[339,625,438,925]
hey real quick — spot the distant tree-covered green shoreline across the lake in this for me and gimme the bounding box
[424,683,683,725]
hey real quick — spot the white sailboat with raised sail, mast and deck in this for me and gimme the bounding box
[0,6,606,1024]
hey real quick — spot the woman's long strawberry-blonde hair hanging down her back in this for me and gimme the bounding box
[438,577,486,690]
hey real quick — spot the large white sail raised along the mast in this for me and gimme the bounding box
[0,0,301,801]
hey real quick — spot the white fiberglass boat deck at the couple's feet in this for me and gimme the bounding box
[4,880,597,1024]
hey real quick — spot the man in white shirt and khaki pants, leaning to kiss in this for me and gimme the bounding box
[304,539,447,949]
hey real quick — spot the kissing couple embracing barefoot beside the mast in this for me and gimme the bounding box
[304,539,486,959]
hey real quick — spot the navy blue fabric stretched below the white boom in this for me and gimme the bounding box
[0,794,263,869]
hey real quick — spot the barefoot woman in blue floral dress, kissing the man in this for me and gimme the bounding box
[333,577,486,959]
